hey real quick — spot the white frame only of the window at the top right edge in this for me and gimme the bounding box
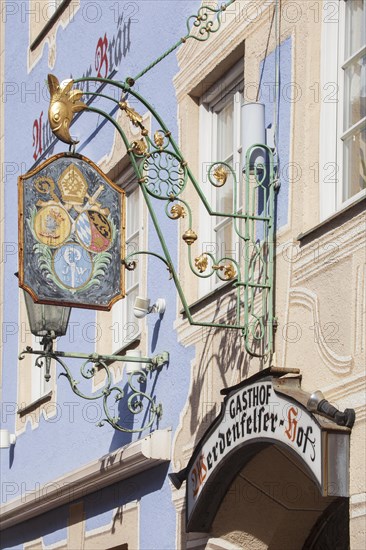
[319,0,366,220]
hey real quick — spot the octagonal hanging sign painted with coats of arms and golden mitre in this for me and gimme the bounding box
[18,153,125,310]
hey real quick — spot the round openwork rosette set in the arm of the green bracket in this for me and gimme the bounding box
[144,151,187,199]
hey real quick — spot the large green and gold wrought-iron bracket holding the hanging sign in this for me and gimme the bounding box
[47,0,278,357]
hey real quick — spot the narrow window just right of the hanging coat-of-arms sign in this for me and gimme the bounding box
[112,171,144,352]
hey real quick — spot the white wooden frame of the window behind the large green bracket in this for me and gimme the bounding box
[199,59,244,296]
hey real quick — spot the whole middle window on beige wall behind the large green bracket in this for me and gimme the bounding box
[200,62,243,290]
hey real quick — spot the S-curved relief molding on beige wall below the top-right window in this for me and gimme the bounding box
[289,287,353,374]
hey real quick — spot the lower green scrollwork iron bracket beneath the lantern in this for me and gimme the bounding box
[19,344,169,433]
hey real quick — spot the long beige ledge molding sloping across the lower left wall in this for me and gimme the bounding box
[0,429,171,529]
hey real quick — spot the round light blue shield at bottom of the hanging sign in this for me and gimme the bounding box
[53,243,93,290]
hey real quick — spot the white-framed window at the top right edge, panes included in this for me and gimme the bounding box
[320,0,366,219]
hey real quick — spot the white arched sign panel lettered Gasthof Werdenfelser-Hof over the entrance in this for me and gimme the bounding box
[186,380,322,521]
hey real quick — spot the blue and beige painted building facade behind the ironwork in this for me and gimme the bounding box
[0,0,366,550]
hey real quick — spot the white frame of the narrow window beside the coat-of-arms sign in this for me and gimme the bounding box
[111,168,145,354]
